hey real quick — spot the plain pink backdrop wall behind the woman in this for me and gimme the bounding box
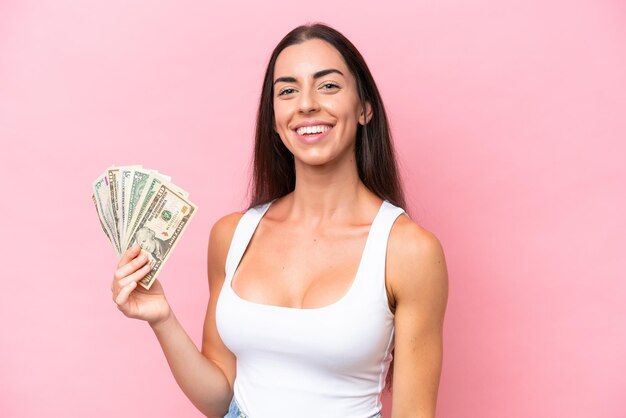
[0,0,626,418]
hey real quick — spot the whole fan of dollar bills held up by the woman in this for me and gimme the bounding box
[92,165,197,289]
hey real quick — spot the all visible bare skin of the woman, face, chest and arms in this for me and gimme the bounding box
[112,39,448,418]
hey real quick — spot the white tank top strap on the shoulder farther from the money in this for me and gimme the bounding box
[361,200,405,285]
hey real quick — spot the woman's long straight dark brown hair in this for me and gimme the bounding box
[250,23,405,212]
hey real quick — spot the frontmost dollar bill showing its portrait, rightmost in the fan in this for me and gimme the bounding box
[128,183,197,289]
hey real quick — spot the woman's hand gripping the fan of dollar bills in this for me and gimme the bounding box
[111,244,171,326]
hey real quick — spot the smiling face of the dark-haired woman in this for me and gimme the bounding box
[273,39,363,165]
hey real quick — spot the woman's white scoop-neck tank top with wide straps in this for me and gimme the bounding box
[216,201,404,418]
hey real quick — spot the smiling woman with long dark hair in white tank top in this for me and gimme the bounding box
[112,24,447,418]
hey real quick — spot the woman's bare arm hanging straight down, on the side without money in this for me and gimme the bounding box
[387,216,448,418]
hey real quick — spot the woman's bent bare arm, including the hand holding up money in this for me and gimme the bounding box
[112,213,241,417]
